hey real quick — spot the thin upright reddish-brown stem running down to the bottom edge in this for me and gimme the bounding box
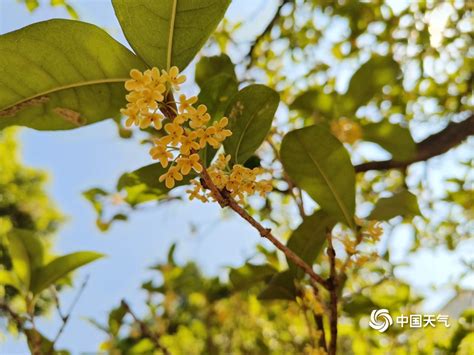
[327,232,338,355]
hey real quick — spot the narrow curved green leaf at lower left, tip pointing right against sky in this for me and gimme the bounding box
[30,251,104,294]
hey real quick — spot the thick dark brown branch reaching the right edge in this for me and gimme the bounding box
[354,114,474,173]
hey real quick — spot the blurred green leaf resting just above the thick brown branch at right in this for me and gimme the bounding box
[362,121,416,161]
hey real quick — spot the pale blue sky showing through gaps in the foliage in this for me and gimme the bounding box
[0,0,472,354]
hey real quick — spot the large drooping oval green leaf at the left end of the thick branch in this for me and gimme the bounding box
[281,125,355,228]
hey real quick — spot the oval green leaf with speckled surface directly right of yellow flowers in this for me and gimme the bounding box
[224,85,280,164]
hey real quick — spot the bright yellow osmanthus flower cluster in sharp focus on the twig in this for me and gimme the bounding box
[121,67,272,202]
